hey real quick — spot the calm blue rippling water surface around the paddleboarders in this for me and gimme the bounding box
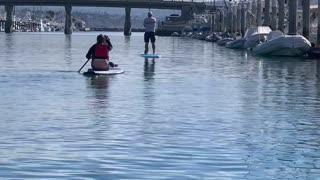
[0,33,320,180]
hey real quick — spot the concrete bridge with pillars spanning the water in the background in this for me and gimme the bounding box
[0,0,207,35]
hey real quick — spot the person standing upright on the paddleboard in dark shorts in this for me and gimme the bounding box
[143,11,157,54]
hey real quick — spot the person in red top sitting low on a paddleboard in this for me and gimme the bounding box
[86,34,117,71]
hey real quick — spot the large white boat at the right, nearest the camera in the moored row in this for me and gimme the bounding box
[252,35,311,57]
